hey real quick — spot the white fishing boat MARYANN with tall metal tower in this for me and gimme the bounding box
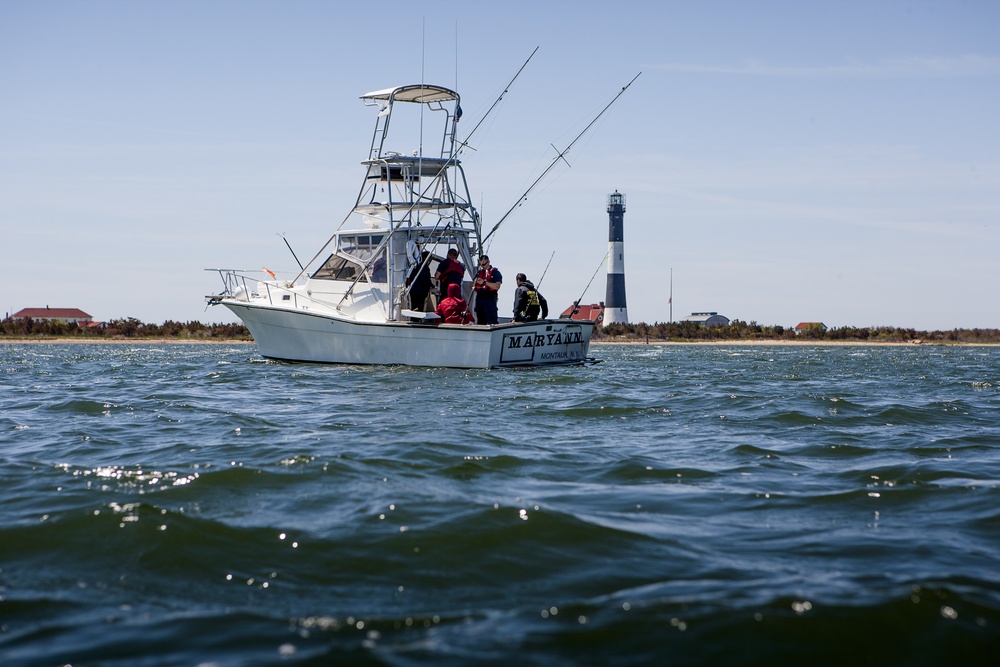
[206,78,624,368]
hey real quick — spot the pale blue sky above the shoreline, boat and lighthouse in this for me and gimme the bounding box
[0,0,1000,330]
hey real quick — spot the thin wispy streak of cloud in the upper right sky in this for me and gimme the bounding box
[652,55,1000,79]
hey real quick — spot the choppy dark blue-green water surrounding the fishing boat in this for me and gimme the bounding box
[0,344,1000,666]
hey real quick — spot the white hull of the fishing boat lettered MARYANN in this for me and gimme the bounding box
[222,299,594,368]
